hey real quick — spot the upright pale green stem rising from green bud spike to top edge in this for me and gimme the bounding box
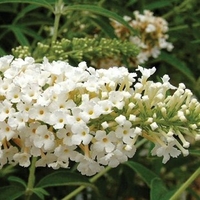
[52,0,64,42]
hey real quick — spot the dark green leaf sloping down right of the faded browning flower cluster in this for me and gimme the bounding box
[158,52,195,82]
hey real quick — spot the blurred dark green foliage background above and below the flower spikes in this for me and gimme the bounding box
[0,0,200,200]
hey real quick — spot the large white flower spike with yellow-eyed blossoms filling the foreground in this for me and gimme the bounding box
[0,55,200,175]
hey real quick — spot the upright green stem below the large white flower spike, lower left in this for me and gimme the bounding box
[25,157,37,200]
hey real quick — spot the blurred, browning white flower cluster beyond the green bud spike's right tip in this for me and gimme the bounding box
[113,10,173,64]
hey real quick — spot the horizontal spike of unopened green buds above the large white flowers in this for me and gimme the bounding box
[12,38,139,63]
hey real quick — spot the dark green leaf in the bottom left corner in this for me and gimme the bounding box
[0,185,25,200]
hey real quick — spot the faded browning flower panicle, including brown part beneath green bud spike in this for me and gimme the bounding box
[92,10,173,68]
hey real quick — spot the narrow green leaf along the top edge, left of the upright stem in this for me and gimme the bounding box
[0,0,53,11]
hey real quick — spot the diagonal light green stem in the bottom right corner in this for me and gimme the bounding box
[170,167,200,200]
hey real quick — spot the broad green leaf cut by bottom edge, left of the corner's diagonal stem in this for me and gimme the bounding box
[150,178,167,200]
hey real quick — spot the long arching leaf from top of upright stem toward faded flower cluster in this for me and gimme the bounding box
[65,5,137,34]
